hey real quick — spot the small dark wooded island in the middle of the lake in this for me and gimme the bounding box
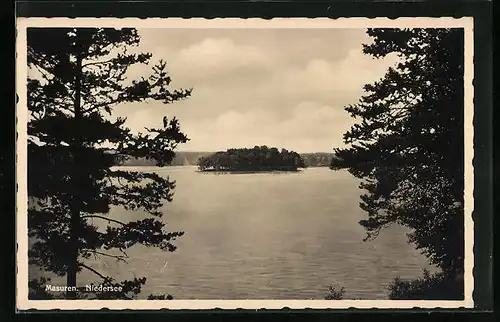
[198,145,306,172]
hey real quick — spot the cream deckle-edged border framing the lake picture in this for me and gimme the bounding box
[16,17,474,310]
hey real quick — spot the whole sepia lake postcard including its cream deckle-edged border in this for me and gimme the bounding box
[17,18,474,309]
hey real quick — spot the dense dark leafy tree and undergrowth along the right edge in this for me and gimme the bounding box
[331,29,464,299]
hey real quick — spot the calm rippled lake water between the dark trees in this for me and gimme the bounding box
[31,167,428,299]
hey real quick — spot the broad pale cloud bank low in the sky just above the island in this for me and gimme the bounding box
[181,101,352,152]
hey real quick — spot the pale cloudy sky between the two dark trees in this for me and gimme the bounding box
[110,29,396,153]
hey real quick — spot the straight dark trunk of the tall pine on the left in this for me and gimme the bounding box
[66,42,82,299]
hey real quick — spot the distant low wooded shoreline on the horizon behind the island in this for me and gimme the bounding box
[107,150,335,172]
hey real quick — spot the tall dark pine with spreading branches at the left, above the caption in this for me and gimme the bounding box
[27,28,191,299]
